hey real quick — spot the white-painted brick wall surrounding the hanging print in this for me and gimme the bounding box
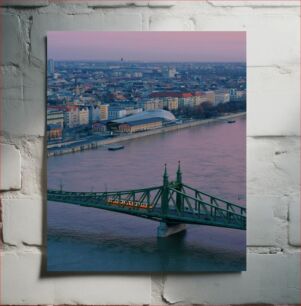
[0,0,300,304]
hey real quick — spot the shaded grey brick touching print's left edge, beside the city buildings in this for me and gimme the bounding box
[1,66,45,136]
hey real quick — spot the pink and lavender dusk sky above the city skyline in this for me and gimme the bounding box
[47,31,246,62]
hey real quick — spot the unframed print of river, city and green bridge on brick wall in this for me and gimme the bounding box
[47,31,247,272]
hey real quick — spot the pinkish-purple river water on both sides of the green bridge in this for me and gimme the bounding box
[47,117,246,272]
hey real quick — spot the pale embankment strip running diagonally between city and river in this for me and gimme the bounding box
[47,112,246,157]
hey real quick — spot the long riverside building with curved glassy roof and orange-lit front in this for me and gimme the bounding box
[107,109,176,133]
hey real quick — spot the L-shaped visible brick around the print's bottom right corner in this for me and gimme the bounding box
[163,253,300,304]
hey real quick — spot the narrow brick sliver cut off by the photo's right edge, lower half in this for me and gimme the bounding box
[288,193,301,247]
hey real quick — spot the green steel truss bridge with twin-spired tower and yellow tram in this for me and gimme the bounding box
[47,163,246,237]
